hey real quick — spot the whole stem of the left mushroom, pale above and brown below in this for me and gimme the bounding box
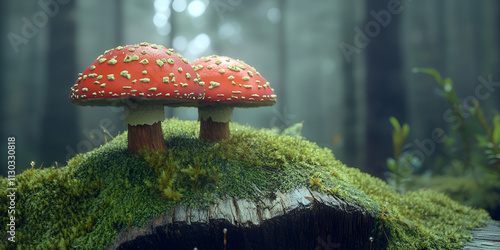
[125,104,167,154]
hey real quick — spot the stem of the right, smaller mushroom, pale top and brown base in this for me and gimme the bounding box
[198,107,233,142]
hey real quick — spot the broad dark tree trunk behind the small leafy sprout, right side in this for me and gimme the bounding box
[361,1,406,177]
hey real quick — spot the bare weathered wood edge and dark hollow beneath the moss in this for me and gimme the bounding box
[109,188,378,249]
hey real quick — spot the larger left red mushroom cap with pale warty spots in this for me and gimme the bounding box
[70,42,204,106]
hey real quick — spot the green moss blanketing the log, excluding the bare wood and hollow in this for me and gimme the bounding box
[0,119,489,249]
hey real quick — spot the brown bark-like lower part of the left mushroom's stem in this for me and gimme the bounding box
[128,122,167,154]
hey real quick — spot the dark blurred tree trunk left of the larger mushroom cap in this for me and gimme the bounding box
[40,1,77,165]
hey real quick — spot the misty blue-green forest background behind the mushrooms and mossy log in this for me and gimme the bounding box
[0,0,500,217]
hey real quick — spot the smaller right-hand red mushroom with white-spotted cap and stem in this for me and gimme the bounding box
[191,55,276,141]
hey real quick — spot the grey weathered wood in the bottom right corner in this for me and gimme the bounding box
[464,222,500,250]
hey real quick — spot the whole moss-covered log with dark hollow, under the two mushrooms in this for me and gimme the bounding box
[0,119,491,249]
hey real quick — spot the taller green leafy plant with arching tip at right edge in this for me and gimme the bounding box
[414,68,500,217]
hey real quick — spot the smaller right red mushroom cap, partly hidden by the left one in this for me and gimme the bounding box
[191,55,276,107]
